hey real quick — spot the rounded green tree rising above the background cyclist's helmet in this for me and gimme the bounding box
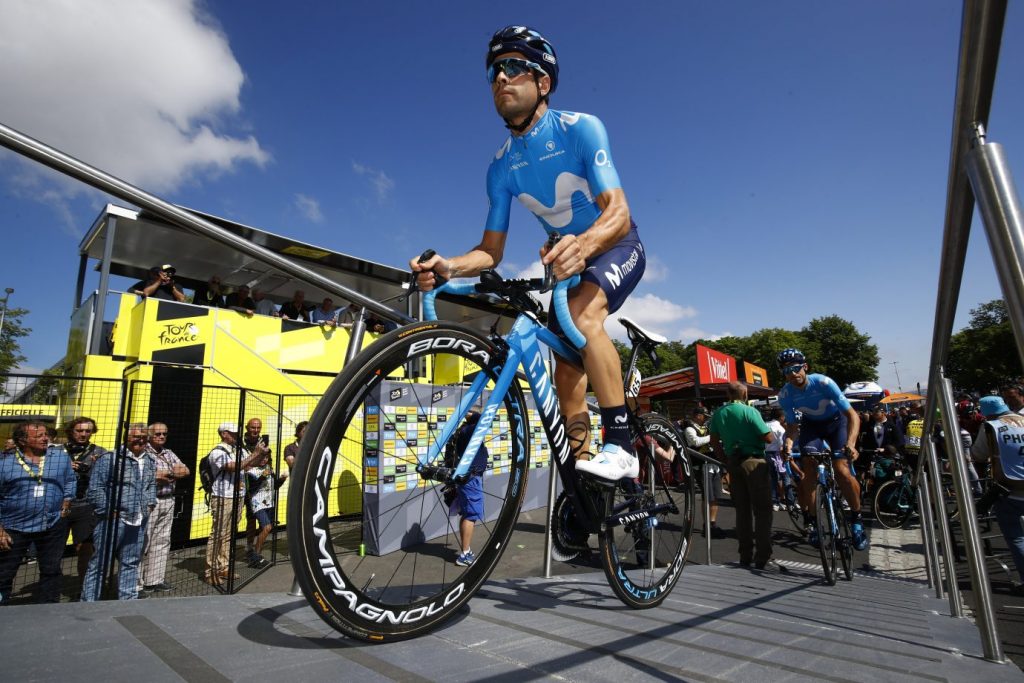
[800,315,879,389]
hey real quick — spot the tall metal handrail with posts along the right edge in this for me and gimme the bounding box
[914,0,1024,661]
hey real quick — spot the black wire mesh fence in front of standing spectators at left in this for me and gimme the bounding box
[0,373,319,604]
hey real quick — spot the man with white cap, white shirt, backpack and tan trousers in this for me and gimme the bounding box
[204,422,258,586]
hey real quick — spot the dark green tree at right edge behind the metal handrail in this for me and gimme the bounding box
[946,299,1024,393]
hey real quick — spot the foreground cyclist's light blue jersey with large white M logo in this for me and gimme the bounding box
[484,110,621,234]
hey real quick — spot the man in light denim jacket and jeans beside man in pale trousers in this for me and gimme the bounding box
[82,422,157,602]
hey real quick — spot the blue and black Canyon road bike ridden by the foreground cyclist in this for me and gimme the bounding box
[288,264,694,642]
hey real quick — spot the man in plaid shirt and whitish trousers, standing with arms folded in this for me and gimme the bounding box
[139,422,189,597]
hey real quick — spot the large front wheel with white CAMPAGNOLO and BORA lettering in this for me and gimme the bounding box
[288,323,529,642]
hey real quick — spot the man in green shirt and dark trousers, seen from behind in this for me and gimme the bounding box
[711,382,781,569]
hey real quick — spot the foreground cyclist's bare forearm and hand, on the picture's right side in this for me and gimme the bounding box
[541,187,631,281]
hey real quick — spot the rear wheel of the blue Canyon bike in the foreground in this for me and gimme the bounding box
[599,414,694,609]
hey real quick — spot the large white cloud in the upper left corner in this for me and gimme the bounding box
[0,0,269,196]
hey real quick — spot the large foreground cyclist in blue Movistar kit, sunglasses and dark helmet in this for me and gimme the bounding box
[410,26,646,480]
